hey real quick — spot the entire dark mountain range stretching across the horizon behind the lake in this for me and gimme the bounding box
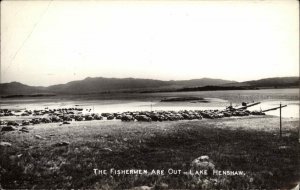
[0,77,299,95]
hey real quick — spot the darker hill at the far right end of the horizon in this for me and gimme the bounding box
[224,77,300,88]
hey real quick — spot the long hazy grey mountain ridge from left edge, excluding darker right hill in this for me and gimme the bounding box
[0,77,235,95]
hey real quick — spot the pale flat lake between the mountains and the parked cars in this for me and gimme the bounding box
[0,88,299,118]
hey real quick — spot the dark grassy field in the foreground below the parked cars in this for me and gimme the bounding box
[0,116,300,189]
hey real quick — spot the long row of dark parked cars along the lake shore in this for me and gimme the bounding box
[0,108,264,126]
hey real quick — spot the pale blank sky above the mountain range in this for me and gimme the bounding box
[0,0,299,86]
